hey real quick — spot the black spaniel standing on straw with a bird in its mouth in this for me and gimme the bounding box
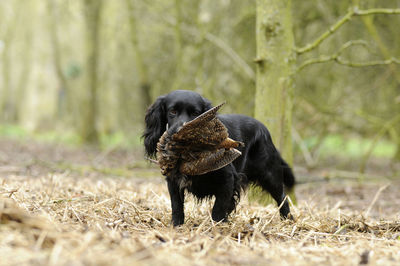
[143,90,295,226]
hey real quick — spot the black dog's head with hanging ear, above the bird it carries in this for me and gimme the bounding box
[143,90,212,156]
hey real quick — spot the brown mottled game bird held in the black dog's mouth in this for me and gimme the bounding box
[157,103,244,176]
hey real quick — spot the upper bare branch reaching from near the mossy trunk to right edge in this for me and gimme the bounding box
[295,7,400,55]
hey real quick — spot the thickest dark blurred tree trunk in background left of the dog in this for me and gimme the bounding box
[81,0,102,144]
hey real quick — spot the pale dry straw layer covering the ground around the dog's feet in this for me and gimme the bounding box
[0,174,400,265]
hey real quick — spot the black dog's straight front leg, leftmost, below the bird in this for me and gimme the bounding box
[167,178,185,226]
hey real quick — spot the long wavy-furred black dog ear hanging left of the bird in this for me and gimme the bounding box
[142,96,167,157]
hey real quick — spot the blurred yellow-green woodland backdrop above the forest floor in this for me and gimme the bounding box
[0,0,400,178]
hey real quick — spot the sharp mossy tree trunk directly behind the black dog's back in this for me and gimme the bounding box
[250,0,295,205]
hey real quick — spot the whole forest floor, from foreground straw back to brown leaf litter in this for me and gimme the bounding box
[0,139,400,265]
